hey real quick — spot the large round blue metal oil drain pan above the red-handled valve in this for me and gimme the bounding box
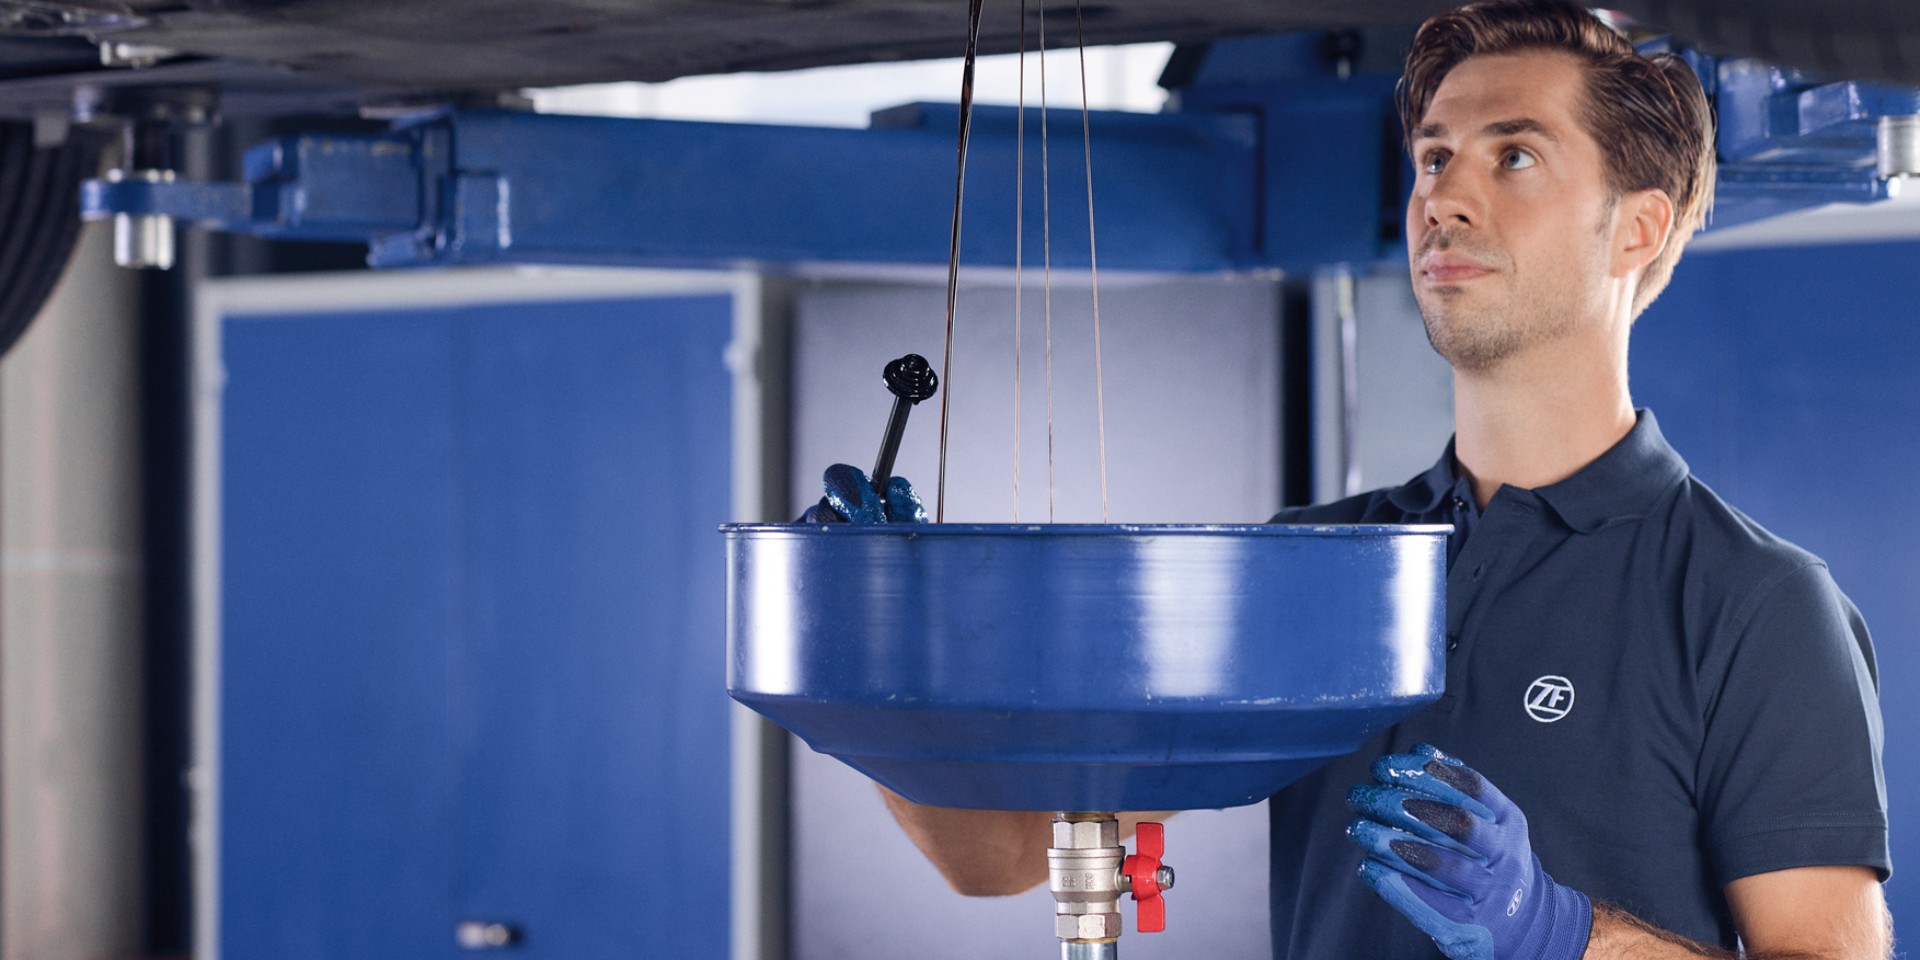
[722,524,1450,810]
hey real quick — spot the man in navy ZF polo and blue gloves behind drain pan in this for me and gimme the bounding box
[808,0,1891,960]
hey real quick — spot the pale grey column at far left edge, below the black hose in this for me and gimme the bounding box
[0,225,146,960]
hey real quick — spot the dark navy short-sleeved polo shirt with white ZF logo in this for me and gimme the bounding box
[1271,411,1891,960]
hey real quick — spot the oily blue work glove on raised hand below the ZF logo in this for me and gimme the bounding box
[1346,743,1594,960]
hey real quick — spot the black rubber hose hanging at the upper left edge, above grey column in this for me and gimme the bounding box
[0,123,104,355]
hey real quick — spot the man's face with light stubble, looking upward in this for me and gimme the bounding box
[1407,52,1615,372]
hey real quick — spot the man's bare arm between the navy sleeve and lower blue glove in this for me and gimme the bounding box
[1586,866,1893,960]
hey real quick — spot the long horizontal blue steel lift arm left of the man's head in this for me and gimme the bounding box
[83,104,1260,271]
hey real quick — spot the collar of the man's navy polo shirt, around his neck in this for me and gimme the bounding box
[1388,409,1688,534]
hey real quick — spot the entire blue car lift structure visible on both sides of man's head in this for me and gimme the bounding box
[83,35,1920,273]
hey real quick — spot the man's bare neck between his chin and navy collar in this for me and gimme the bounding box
[1453,338,1634,507]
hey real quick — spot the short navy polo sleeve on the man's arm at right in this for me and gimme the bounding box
[1695,561,1891,883]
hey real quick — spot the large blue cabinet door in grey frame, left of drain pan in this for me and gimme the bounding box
[217,288,733,960]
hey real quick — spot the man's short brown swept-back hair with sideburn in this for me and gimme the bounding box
[1398,0,1715,317]
